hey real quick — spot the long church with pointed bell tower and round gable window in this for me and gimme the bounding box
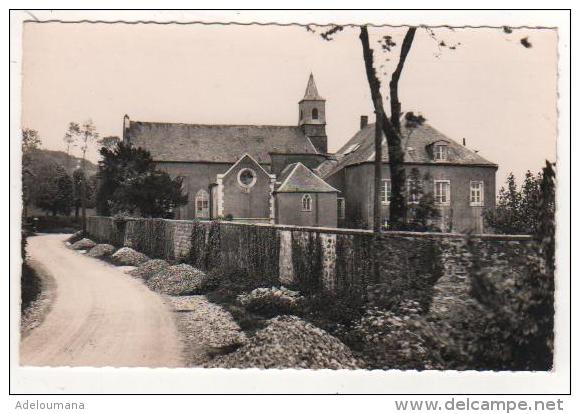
[123,74,339,227]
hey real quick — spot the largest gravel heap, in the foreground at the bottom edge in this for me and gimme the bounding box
[206,315,364,369]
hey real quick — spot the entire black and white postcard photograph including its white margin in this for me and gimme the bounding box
[10,10,570,393]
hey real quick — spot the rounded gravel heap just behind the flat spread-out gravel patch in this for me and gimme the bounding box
[147,264,209,296]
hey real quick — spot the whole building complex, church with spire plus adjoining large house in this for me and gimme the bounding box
[123,74,498,233]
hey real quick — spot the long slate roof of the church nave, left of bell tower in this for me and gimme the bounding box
[127,121,318,164]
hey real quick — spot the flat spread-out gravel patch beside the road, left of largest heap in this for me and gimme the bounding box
[168,296,248,366]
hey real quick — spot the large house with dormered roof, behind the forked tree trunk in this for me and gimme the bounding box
[317,116,498,233]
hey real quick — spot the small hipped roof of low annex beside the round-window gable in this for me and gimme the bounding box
[276,162,339,193]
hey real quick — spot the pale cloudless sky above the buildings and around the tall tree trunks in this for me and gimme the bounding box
[22,22,557,187]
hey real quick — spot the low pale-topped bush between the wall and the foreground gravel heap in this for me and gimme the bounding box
[237,286,304,317]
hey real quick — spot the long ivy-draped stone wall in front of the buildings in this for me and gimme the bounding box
[88,217,534,312]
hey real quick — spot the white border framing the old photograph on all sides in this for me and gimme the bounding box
[4,8,578,396]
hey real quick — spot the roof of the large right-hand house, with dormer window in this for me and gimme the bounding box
[317,119,497,178]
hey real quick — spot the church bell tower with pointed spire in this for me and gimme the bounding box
[298,73,328,154]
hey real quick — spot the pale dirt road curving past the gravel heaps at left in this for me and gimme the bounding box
[20,235,182,367]
